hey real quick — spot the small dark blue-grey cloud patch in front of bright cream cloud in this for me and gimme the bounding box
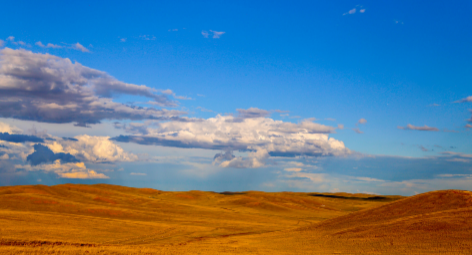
[26,144,80,166]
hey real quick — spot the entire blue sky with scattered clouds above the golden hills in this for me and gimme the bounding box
[0,1,472,195]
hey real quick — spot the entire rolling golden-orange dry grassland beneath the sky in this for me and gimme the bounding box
[0,184,472,254]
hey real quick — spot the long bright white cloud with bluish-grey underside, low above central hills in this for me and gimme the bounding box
[112,114,350,167]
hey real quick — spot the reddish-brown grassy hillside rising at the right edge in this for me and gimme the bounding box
[254,190,472,254]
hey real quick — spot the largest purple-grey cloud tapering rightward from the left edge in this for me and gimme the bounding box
[0,48,184,126]
